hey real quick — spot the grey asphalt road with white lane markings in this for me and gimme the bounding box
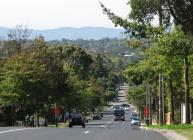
[0,86,166,140]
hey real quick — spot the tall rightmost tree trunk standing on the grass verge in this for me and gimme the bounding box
[184,56,190,124]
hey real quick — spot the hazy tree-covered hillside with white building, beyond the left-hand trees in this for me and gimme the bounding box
[47,38,139,66]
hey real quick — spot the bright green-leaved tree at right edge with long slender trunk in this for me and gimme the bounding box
[156,29,193,123]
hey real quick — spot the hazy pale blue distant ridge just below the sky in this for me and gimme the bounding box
[0,27,124,40]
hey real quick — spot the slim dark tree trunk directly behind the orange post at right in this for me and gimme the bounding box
[169,73,175,123]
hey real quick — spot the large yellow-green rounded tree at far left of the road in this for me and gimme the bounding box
[0,39,67,124]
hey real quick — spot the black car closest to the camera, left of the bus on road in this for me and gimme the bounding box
[69,115,85,128]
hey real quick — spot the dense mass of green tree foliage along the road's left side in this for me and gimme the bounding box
[0,36,123,126]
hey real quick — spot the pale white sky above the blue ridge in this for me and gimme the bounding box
[0,0,129,29]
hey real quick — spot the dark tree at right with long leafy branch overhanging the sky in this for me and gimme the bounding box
[101,0,193,123]
